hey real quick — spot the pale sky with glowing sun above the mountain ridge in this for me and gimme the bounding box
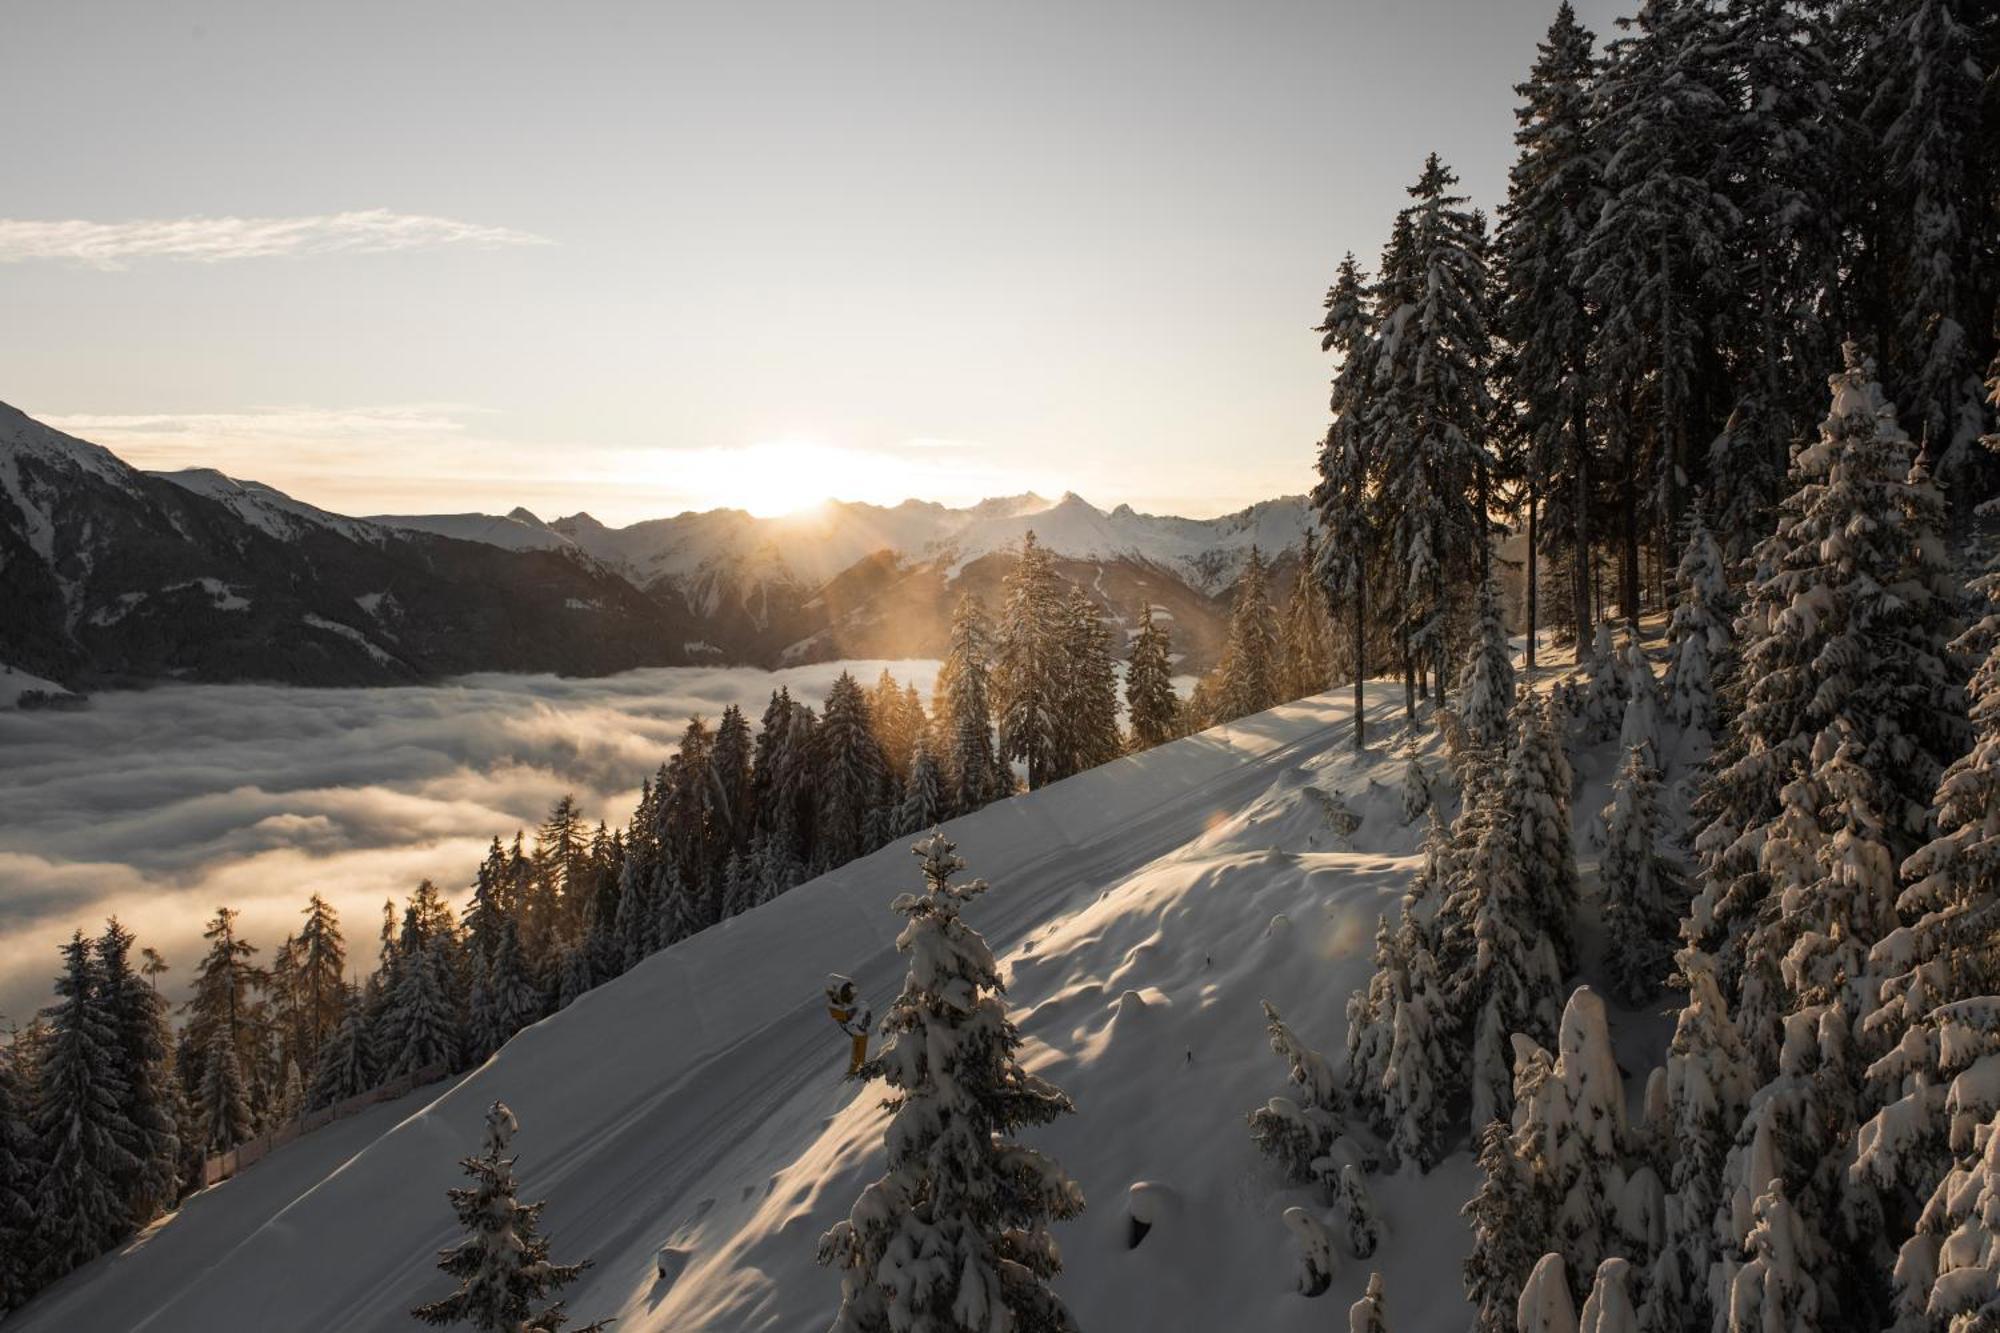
[0,0,1624,522]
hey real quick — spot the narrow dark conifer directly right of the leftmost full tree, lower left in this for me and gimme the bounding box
[96,917,180,1225]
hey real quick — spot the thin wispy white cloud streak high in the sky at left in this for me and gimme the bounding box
[0,208,552,270]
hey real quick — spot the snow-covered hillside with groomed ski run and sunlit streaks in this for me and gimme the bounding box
[10,685,1472,1333]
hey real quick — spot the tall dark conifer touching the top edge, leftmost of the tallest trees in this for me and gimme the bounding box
[1496,0,1604,684]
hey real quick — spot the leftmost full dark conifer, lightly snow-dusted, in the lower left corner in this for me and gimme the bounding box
[32,931,139,1285]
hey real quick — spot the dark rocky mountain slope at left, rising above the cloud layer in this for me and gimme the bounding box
[0,404,692,689]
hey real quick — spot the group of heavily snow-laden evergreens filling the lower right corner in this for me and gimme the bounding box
[1250,344,2000,1333]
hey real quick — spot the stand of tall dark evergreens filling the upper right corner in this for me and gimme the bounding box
[1314,0,2000,748]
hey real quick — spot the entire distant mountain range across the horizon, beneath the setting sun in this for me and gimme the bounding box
[0,404,1308,689]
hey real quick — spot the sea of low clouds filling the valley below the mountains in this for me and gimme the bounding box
[0,660,938,1021]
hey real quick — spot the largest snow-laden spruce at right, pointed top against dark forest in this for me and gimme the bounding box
[1692,344,1964,1000]
